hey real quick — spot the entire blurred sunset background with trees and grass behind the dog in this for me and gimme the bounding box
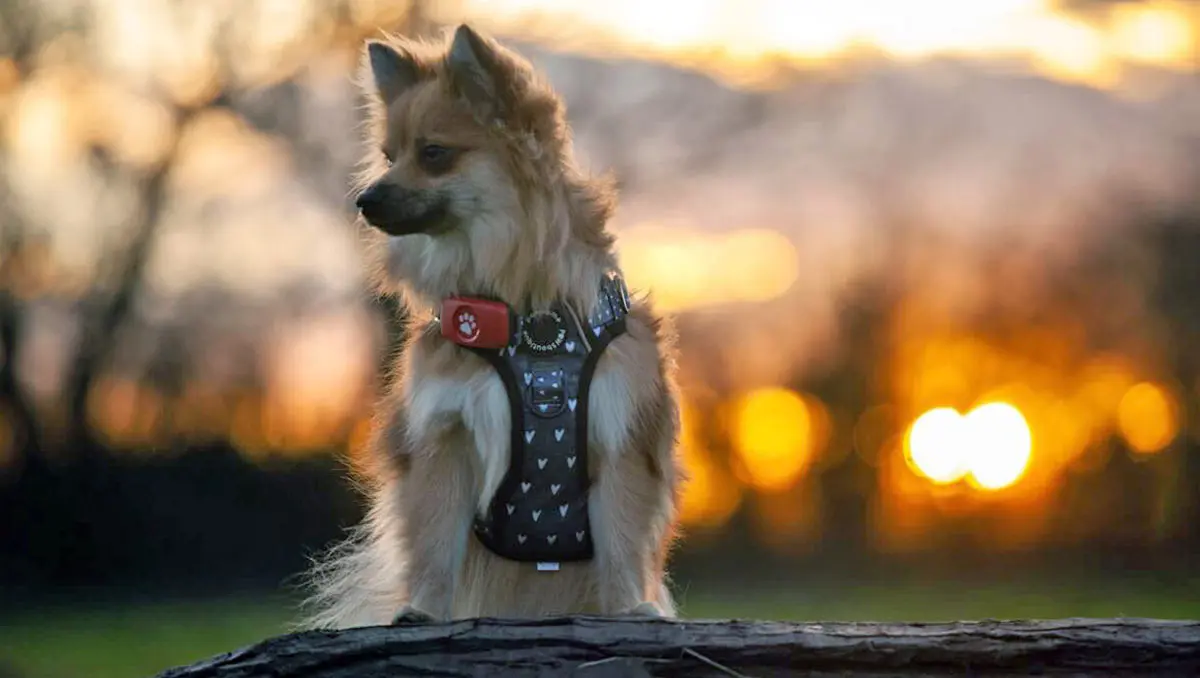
[0,0,1200,677]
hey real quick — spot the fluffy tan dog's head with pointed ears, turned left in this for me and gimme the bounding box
[356,25,611,309]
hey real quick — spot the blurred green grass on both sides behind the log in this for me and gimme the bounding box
[0,581,1200,678]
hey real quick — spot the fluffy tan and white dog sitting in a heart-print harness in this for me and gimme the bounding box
[307,25,684,628]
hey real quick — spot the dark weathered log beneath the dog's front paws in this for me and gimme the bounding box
[152,617,1200,678]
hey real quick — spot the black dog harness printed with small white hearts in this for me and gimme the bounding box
[448,274,630,570]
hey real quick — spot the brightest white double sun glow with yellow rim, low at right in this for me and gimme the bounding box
[905,402,1033,490]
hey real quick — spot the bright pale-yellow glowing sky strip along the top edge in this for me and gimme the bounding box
[434,0,1200,86]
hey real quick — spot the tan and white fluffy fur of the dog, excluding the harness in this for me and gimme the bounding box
[306,26,682,628]
